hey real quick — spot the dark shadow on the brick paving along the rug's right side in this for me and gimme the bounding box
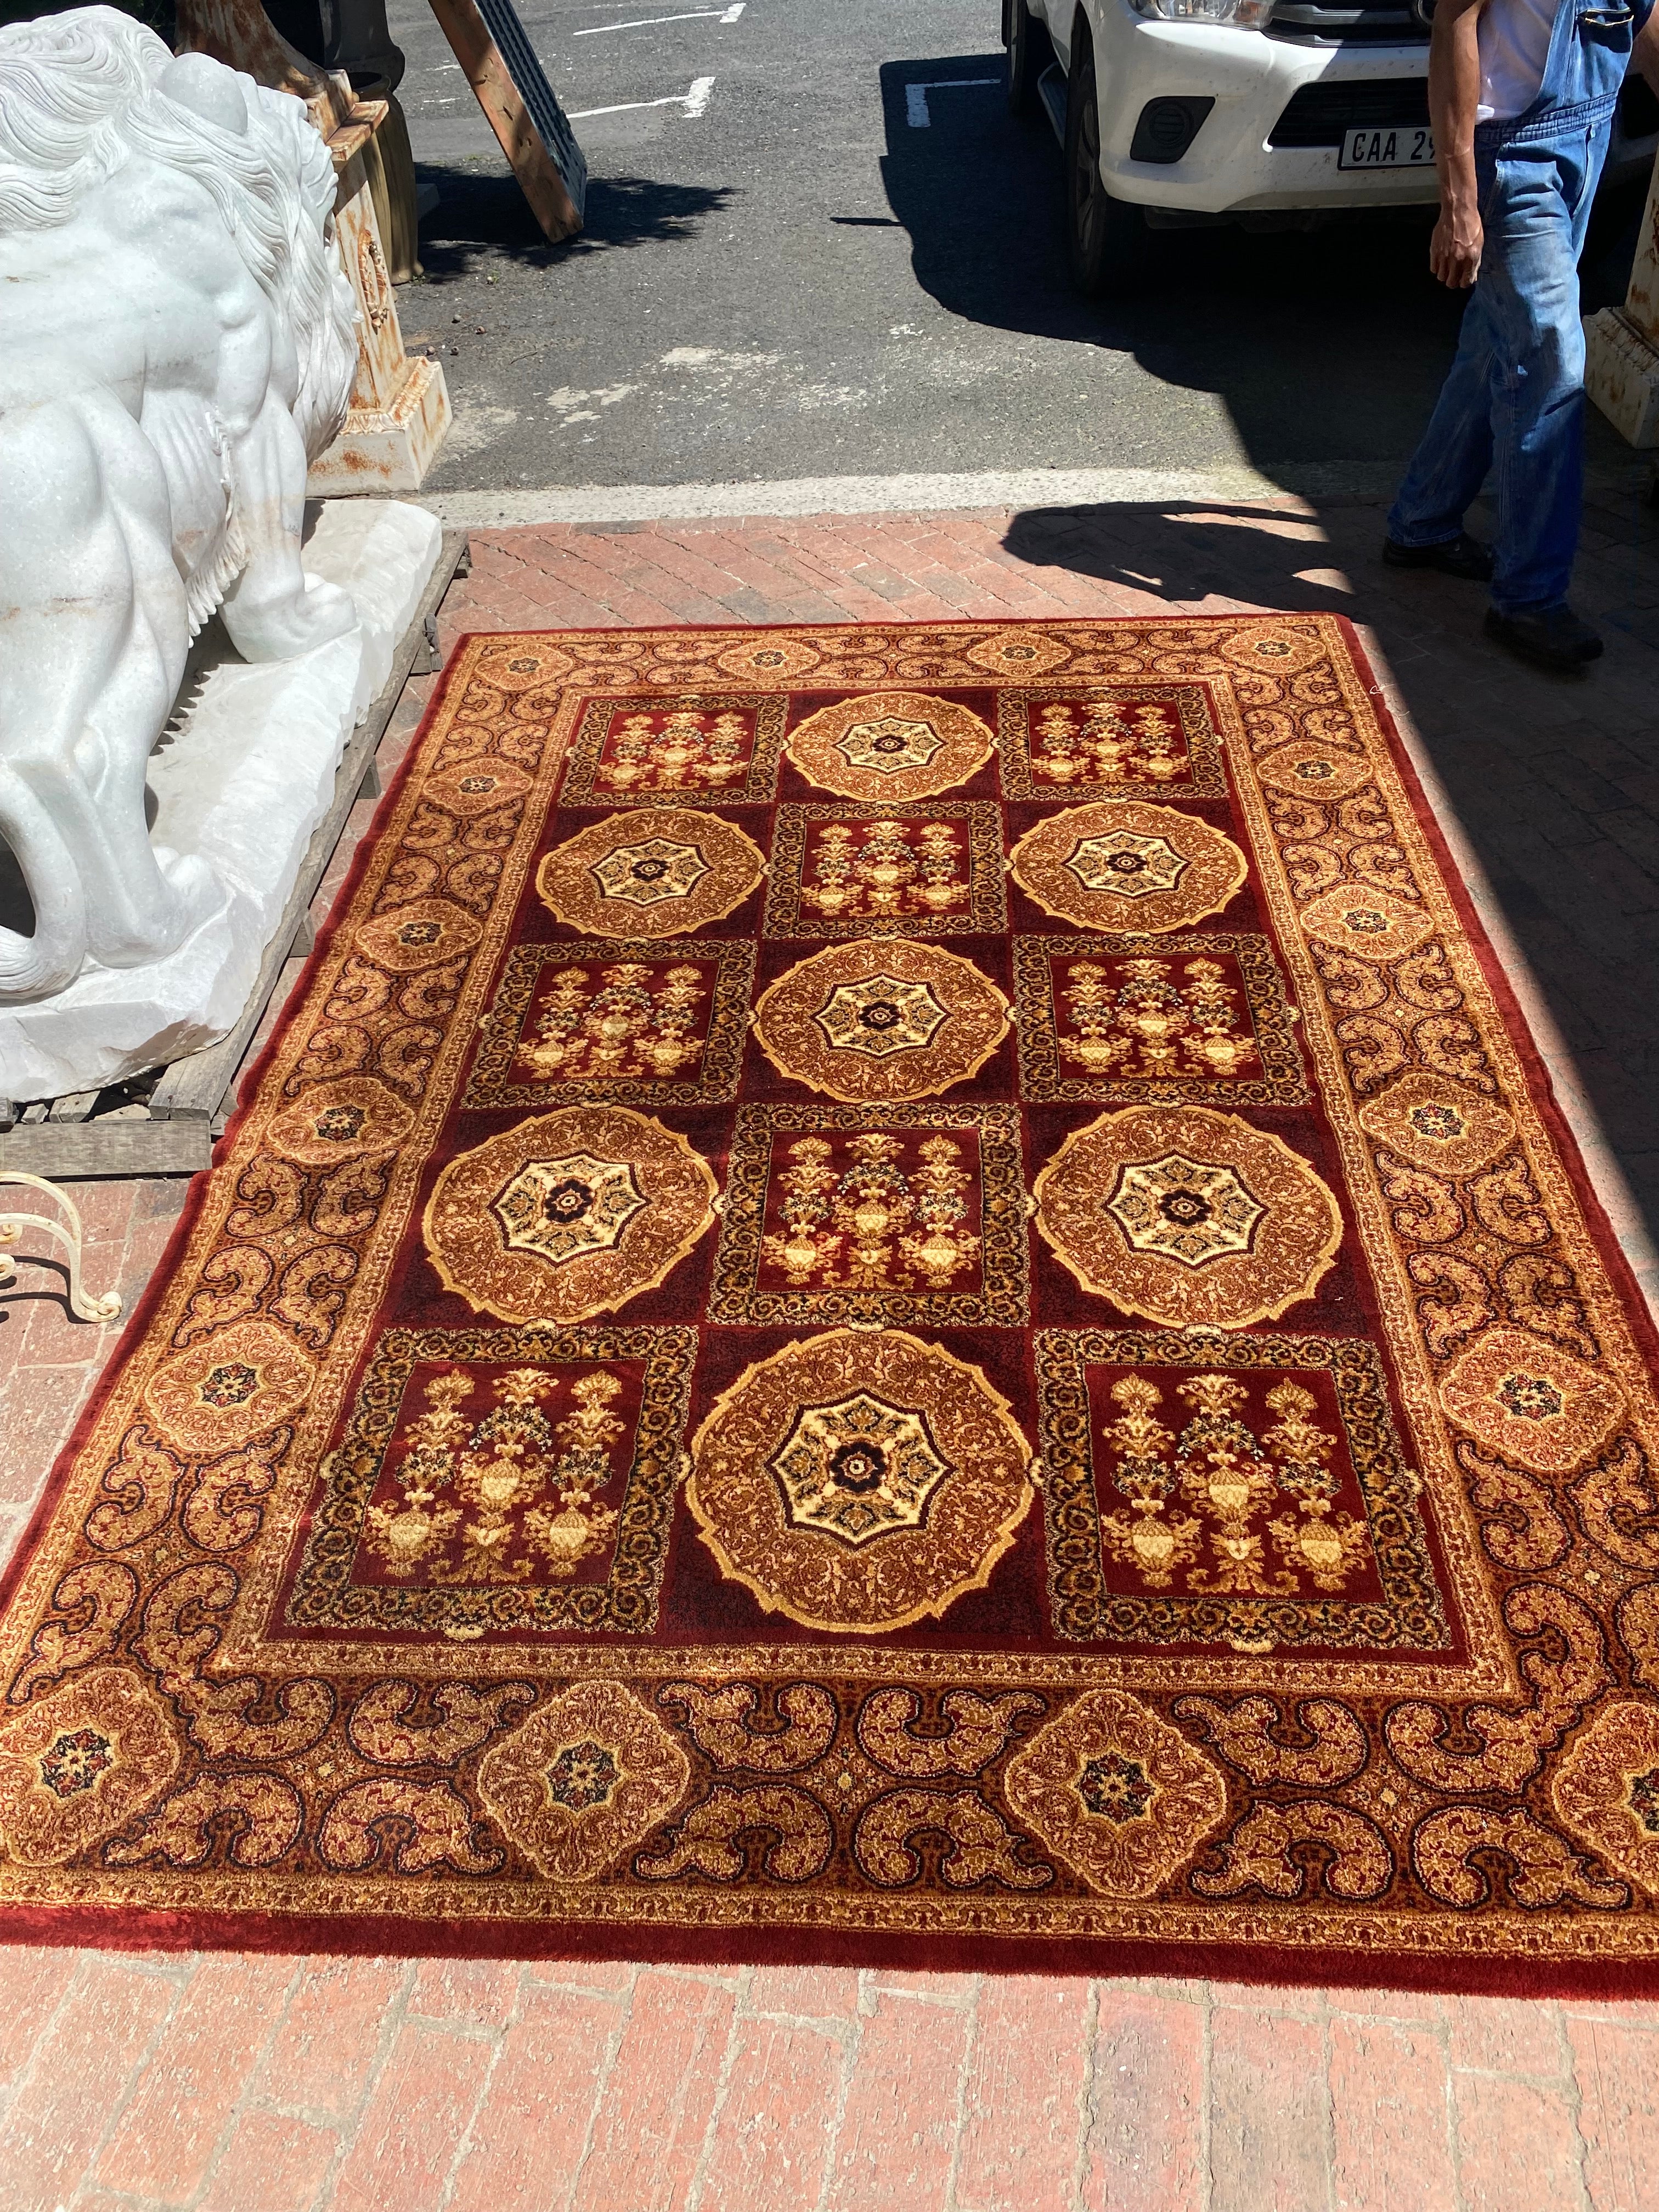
[1002,487,1659,1241]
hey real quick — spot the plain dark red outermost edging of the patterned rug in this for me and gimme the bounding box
[0,608,1659,2000]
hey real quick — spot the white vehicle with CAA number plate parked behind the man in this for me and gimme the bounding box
[1002,0,1659,292]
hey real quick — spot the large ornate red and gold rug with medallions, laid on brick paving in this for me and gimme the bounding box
[0,615,1659,1991]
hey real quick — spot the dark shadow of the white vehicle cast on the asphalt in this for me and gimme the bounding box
[881,49,1639,489]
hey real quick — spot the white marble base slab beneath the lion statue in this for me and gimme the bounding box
[0,500,442,1099]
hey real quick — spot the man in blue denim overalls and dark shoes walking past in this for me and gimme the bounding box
[1383,0,1659,668]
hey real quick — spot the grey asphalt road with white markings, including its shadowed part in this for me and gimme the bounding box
[390,0,1635,493]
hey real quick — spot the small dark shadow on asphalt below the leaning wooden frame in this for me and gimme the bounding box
[416,161,737,281]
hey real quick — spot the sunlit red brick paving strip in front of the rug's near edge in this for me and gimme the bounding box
[0,1951,1659,2212]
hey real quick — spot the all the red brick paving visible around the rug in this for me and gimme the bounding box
[0,493,1659,2212]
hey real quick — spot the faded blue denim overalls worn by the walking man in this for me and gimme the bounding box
[1387,0,1652,615]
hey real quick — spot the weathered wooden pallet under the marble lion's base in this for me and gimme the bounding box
[0,531,471,1181]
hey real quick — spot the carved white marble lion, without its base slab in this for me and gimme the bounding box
[0,7,356,1000]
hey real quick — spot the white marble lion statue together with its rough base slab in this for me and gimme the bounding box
[0,7,455,1102]
